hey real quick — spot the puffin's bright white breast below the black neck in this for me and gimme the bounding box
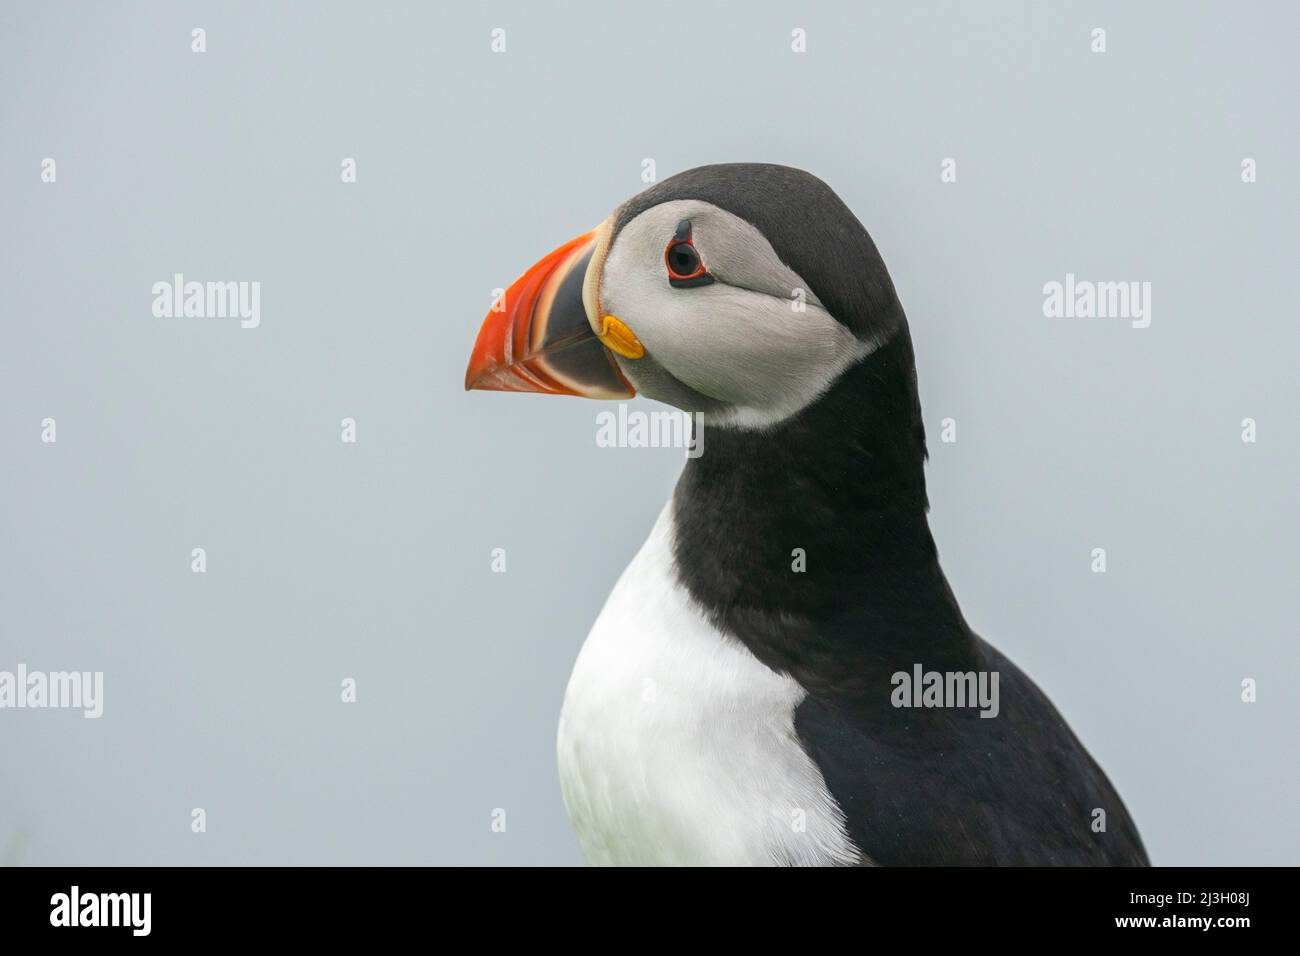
[558,506,861,865]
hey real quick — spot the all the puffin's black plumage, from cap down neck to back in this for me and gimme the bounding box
[660,165,1148,865]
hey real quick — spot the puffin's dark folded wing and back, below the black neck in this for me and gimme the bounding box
[794,641,1151,866]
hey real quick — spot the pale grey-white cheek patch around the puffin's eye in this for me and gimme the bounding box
[599,199,872,428]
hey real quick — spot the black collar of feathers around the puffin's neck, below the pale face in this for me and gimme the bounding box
[672,325,975,695]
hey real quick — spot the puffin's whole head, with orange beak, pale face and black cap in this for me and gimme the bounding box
[465,163,906,428]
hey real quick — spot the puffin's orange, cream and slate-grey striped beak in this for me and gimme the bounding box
[465,224,636,398]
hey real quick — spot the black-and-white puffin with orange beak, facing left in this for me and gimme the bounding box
[465,163,1149,866]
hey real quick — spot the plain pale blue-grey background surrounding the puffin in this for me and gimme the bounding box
[0,3,1300,864]
